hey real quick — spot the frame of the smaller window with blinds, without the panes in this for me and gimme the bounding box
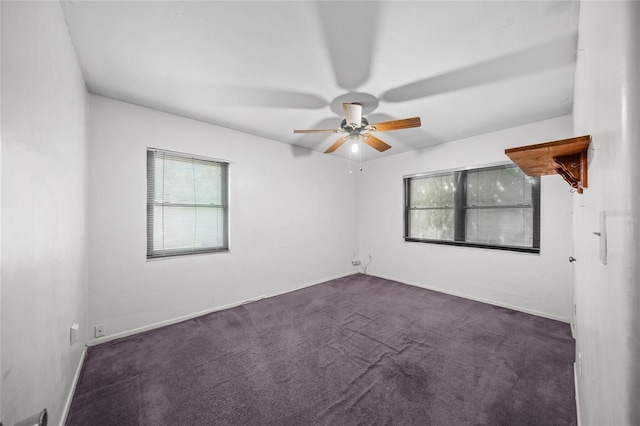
[146,147,230,260]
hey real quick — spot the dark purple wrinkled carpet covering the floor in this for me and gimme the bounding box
[66,274,576,426]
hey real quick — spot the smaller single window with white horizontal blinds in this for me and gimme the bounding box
[147,148,229,258]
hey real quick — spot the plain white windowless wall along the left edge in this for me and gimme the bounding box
[1,1,87,425]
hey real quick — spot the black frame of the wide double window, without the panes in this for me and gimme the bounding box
[403,162,541,254]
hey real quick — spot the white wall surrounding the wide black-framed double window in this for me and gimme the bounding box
[359,116,574,321]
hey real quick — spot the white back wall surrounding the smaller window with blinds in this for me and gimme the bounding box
[89,95,358,337]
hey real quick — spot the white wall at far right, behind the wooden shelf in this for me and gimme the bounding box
[574,1,640,425]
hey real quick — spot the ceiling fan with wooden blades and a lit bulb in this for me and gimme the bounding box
[293,102,420,154]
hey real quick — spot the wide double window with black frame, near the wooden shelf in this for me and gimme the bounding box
[404,164,540,253]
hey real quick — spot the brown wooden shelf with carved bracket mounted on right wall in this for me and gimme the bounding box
[504,135,591,194]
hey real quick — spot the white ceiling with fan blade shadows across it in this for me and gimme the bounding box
[61,0,579,160]
